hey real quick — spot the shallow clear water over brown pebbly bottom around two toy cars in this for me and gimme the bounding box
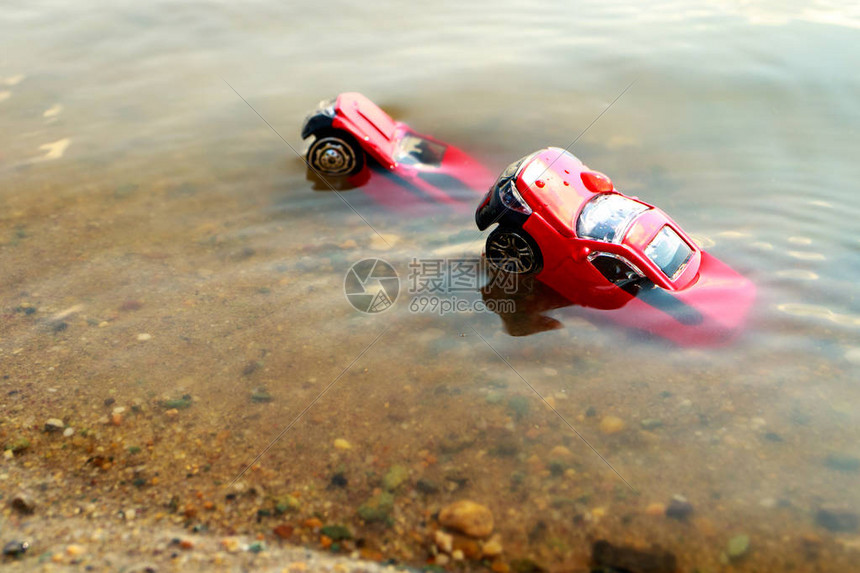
[0,1,860,570]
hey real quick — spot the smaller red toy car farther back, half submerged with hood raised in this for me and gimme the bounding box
[301,93,492,209]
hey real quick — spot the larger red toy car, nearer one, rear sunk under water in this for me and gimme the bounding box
[475,148,755,343]
